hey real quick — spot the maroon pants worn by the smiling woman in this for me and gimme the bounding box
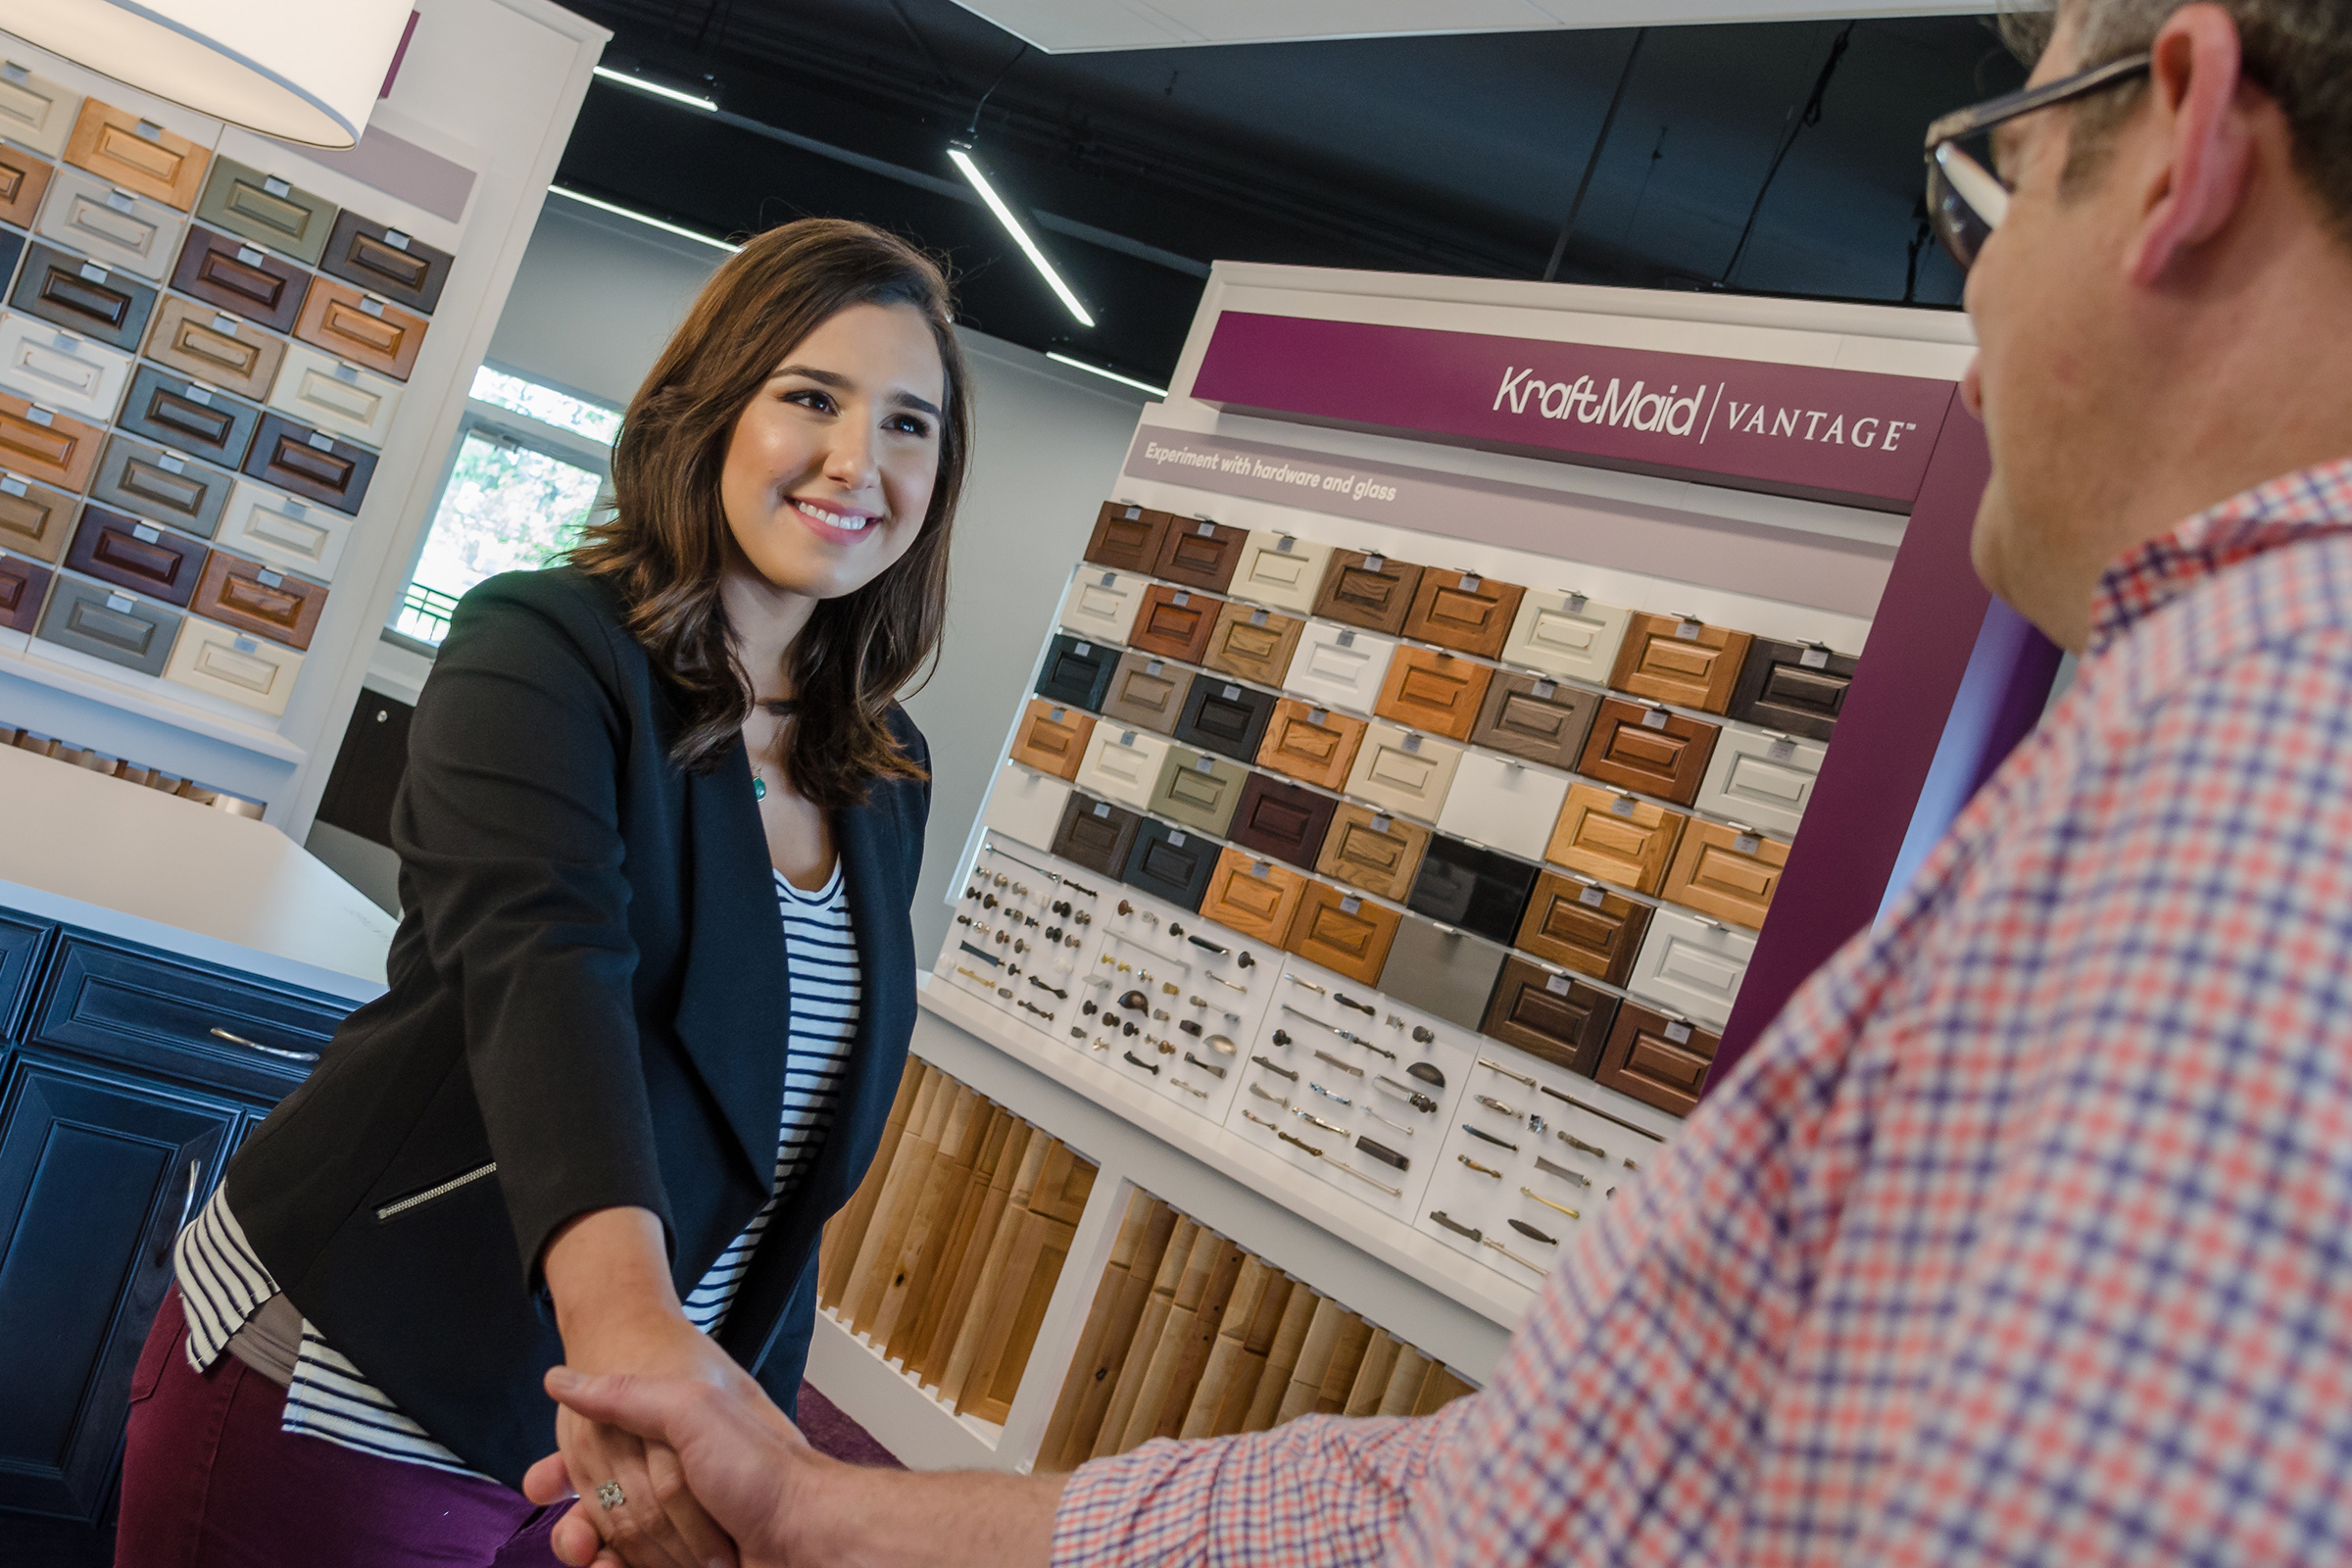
[116,1291,569,1568]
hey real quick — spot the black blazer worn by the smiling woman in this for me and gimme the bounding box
[228,569,931,1486]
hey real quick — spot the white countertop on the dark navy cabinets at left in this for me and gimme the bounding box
[0,748,398,1002]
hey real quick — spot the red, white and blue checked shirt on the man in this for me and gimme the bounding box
[1054,459,2352,1568]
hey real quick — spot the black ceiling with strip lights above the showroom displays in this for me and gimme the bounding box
[558,0,2023,381]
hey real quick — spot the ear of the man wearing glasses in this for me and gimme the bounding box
[2127,2,2253,289]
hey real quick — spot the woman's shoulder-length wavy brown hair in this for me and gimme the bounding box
[569,219,971,808]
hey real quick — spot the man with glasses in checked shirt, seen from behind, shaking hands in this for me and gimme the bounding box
[534,0,2352,1568]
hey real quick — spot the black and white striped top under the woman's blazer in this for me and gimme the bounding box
[174,862,860,1474]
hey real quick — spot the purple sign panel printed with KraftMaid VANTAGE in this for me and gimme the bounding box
[1193,311,1954,513]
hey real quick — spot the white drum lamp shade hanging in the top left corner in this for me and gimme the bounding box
[0,0,412,148]
